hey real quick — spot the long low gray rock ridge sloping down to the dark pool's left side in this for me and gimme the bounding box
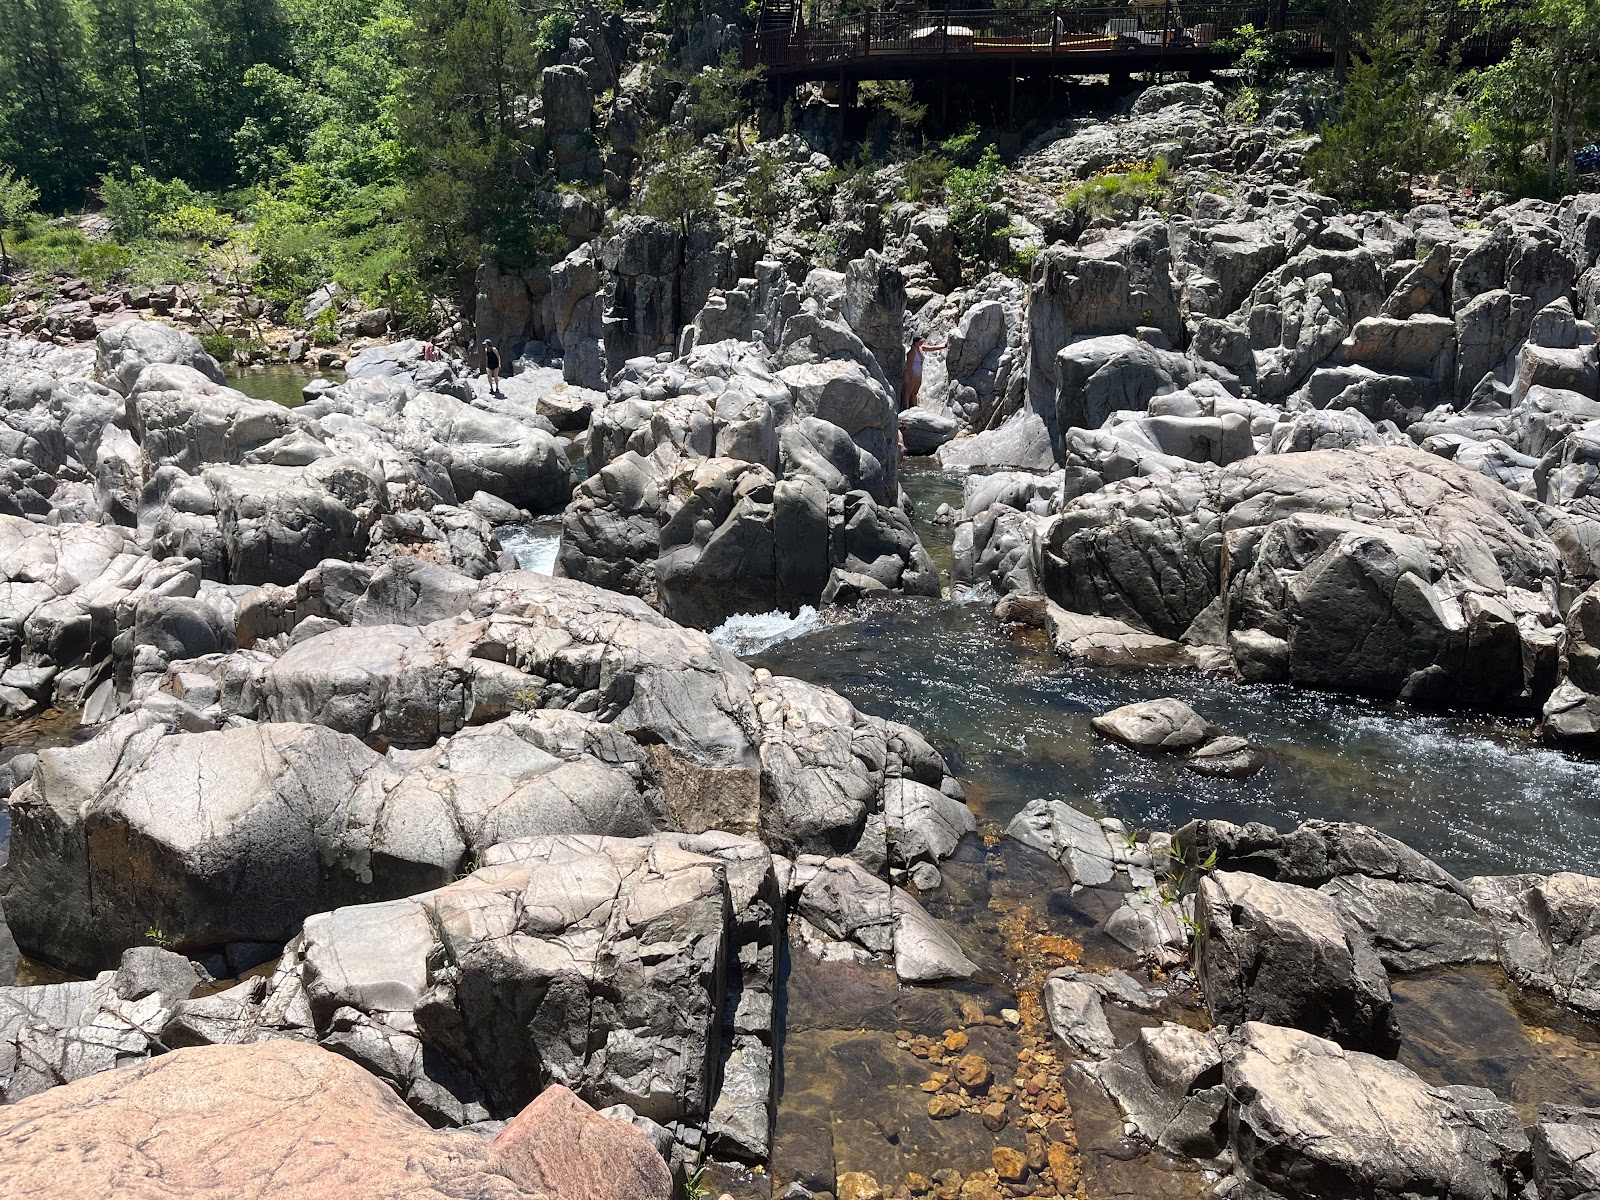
[140,563,971,867]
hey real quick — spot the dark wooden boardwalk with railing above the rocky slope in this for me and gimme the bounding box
[744,0,1507,83]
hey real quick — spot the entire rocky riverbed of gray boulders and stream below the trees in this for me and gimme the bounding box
[0,67,1600,1200]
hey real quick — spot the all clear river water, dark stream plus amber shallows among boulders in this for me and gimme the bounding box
[0,422,1600,1200]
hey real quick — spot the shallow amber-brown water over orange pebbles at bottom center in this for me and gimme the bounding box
[755,837,1203,1200]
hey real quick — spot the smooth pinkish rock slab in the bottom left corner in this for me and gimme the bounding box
[0,1040,672,1200]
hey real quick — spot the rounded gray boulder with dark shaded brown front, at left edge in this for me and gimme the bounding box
[5,718,461,968]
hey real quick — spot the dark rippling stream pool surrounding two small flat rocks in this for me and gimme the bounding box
[750,598,1600,875]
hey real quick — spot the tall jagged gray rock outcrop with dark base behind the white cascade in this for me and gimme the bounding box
[557,334,939,629]
